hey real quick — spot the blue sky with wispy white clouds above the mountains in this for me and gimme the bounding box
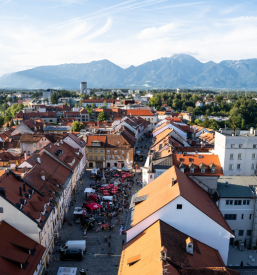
[0,0,257,75]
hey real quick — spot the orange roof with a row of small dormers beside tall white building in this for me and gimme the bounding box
[172,154,223,176]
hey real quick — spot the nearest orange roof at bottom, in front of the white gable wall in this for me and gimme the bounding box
[118,220,230,275]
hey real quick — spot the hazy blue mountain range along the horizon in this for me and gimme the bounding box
[0,54,257,90]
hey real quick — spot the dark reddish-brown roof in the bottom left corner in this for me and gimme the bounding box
[0,221,45,275]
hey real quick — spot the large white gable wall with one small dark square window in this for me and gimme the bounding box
[127,196,232,265]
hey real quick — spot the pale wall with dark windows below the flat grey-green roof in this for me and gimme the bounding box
[217,198,255,240]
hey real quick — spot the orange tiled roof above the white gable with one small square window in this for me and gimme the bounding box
[132,165,231,233]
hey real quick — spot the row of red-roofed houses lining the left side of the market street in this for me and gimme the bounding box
[0,129,86,275]
